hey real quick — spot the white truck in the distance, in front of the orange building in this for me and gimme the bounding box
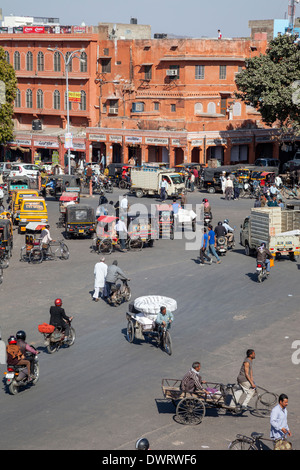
[131,167,185,197]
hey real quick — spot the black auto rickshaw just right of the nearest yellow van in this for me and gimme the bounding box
[65,204,95,237]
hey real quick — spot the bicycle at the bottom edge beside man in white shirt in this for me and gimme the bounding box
[228,432,292,450]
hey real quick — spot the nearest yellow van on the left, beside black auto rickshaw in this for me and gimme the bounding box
[17,197,48,233]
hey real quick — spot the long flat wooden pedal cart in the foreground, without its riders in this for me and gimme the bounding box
[162,379,278,425]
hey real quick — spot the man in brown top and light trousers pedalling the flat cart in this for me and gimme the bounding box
[230,349,256,410]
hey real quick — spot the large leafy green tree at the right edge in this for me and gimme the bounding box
[236,35,300,133]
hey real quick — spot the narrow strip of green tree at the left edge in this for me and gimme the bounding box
[0,47,17,144]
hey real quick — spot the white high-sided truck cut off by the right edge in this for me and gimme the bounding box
[240,207,300,261]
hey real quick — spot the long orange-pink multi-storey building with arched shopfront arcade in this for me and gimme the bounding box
[0,27,290,166]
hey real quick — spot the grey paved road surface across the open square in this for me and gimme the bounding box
[0,191,300,450]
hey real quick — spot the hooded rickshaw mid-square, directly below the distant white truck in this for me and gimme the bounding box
[127,212,159,250]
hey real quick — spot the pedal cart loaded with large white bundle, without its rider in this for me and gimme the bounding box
[126,295,177,356]
